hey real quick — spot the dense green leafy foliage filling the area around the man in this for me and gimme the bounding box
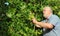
[0,0,60,36]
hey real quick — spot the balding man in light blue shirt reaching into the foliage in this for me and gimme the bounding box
[32,6,60,36]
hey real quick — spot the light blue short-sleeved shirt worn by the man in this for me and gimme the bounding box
[43,14,60,36]
